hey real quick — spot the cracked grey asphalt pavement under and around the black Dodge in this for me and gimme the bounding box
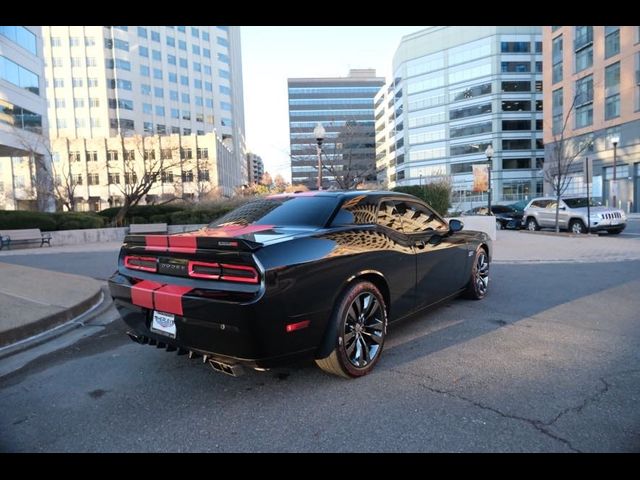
[0,253,640,452]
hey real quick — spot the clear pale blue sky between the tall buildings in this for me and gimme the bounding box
[240,26,426,181]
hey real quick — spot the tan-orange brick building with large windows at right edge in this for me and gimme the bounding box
[543,25,640,212]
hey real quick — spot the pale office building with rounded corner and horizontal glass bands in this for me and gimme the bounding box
[376,26,544,207]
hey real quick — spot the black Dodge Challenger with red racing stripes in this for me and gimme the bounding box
[109,191,492,377]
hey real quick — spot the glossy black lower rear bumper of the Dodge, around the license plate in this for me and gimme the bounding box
[109,274,327,368]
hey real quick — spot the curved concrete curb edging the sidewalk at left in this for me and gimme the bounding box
[0,287,107,358]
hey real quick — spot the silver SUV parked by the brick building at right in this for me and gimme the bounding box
[522,197,627,234]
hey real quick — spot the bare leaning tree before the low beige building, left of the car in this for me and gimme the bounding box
[113,134,182,225]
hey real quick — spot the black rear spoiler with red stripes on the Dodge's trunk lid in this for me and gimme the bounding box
[123,232,263,253]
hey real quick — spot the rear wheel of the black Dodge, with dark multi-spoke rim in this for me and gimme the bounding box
[315,281,387,378]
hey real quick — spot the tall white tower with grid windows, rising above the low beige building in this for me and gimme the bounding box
[43,26,246,201]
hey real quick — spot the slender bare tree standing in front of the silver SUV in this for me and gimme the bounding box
[544,90,594,232]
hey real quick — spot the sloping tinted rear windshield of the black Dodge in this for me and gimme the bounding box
[209,196,338,227]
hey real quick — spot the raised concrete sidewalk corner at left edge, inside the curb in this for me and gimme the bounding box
[0,263,103,355]
